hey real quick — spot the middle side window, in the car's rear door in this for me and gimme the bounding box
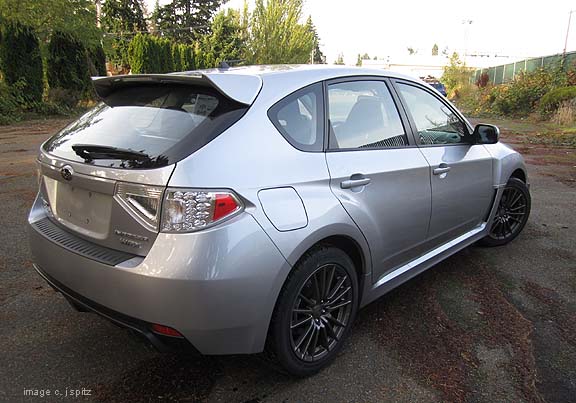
[328,81,408,149]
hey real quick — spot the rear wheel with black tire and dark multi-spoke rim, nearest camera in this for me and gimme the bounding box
[267,245,359,377]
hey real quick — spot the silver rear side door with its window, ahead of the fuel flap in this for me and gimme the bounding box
[326,78,431,281]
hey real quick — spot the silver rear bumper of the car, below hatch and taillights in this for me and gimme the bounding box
[29,197,290,354]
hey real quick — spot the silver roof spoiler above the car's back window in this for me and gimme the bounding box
[92,72,262,105]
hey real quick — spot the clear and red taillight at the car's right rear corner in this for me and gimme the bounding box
[161,189,242,233]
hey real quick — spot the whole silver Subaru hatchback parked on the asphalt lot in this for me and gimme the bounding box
[29,66,530,376]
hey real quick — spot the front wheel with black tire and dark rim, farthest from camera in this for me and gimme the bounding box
[480,178,531,246]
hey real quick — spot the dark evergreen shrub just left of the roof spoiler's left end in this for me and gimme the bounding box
[47,31,90,94]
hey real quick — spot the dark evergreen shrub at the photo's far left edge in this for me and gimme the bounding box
[0,21,44,107]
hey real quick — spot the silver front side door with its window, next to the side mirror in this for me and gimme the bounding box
[395,80,494,243]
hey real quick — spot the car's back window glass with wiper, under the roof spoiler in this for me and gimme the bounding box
[44,84,248,169]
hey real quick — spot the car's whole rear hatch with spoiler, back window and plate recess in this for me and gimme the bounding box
[39,73,261,256]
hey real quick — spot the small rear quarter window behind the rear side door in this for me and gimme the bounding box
[268,84,324,151]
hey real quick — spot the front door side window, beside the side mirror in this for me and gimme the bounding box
[398,84,470,144]
